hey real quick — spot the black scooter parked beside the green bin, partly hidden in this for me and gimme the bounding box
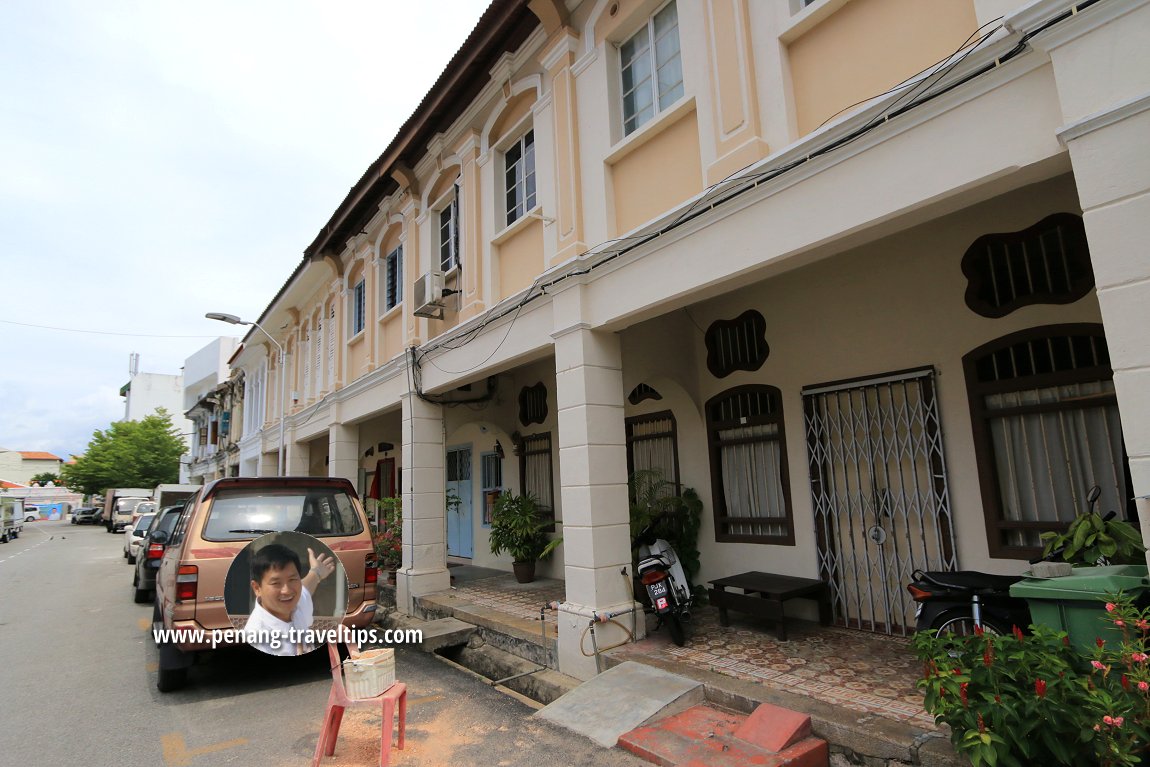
[906,485,1114,635]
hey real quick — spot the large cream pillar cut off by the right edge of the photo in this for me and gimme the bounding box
[1019,0,1150,533]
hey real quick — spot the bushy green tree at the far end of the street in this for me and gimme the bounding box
[61,407,185,494]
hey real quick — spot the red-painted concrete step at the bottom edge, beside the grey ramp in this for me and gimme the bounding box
[619,705,830,767]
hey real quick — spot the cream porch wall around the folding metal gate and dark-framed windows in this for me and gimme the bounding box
[623,177,1101,580]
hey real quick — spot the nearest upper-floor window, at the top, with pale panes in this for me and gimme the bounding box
[619,2,683,136]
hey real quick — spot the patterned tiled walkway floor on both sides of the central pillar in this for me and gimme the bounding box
[439,572,935,729]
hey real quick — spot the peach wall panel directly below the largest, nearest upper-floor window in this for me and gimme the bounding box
[611,112,703,235]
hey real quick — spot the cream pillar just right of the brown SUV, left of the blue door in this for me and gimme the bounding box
[396,393,451,615]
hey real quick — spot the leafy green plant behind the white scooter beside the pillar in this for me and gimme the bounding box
[627,469,703,581]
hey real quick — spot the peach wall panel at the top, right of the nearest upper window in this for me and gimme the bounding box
[788,0,979,136]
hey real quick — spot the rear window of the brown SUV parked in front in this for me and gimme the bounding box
[197,488,363,540]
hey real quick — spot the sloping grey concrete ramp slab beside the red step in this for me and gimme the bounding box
[535,661,704,749]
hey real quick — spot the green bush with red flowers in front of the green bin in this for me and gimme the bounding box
[914,595,1150,767]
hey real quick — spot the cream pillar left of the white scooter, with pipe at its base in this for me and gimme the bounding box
[553,323,643,680]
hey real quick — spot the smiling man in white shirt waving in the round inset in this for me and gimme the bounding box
[244,543,336,655]
